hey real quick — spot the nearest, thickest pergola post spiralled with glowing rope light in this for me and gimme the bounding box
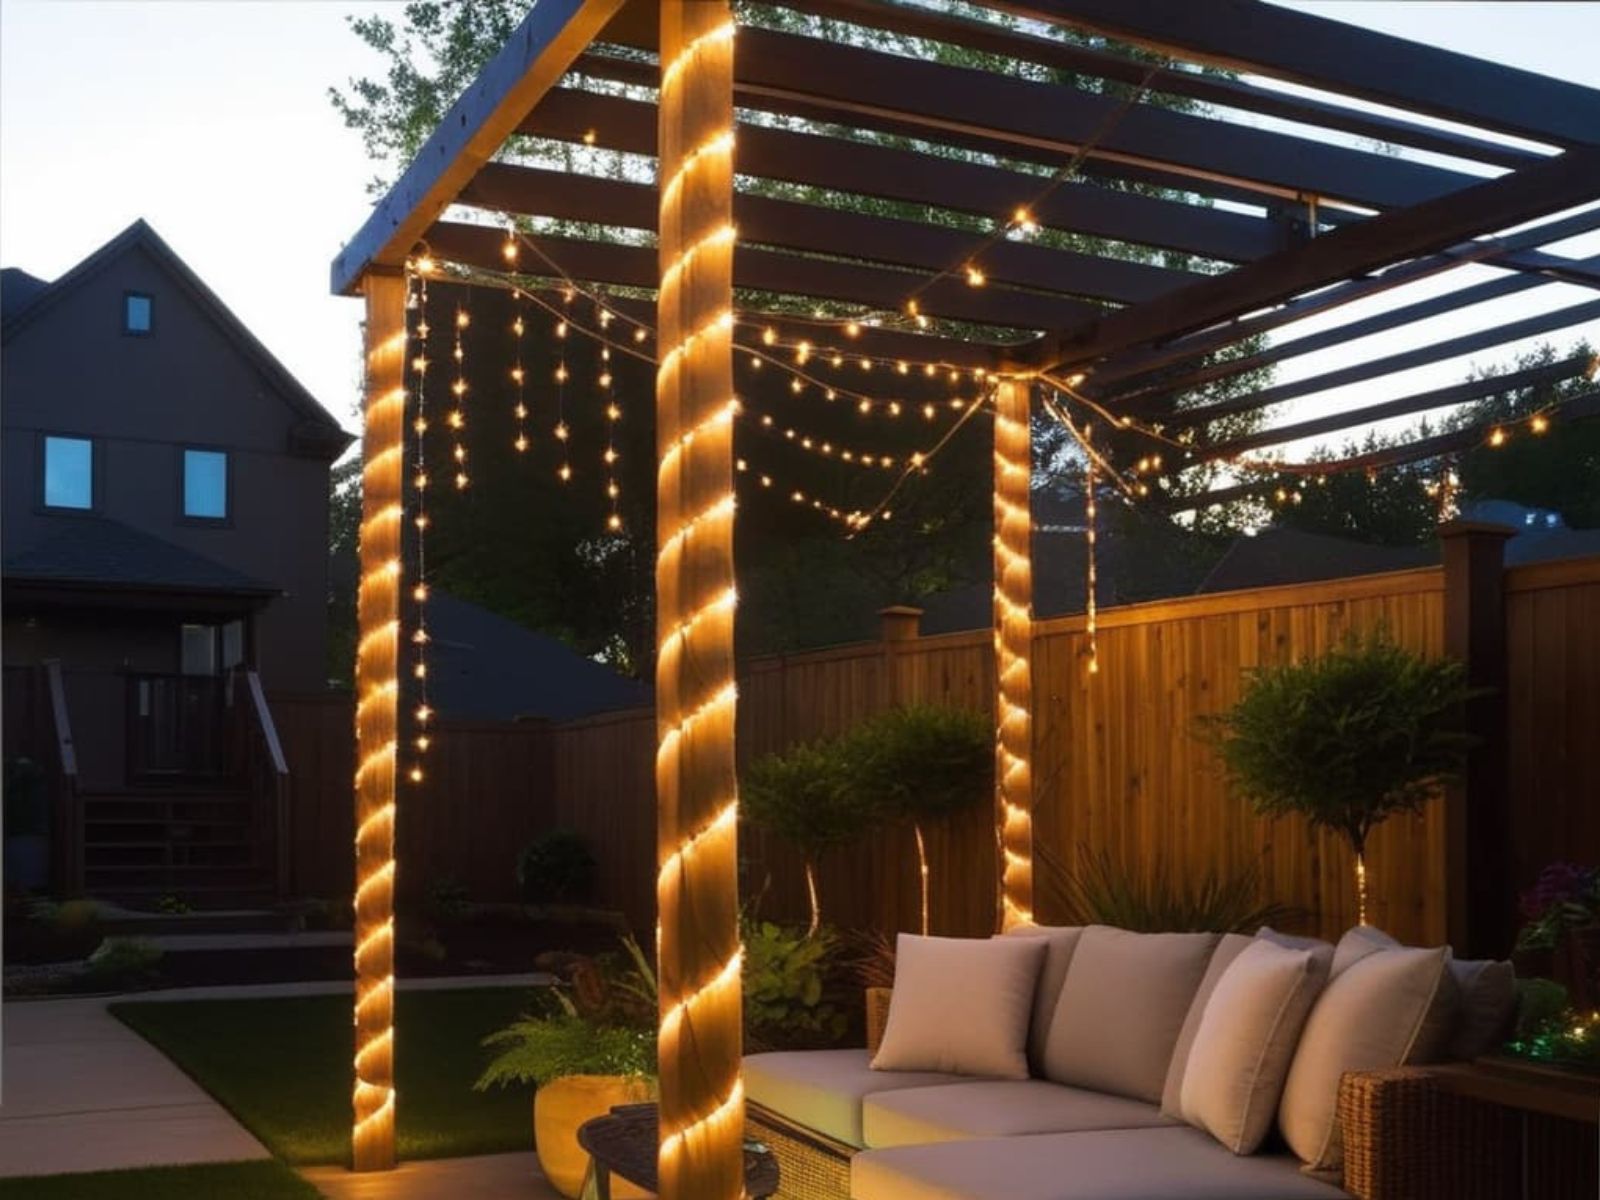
[656,0,744,1200]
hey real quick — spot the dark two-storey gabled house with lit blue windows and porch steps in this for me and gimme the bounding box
[0,221,352,893]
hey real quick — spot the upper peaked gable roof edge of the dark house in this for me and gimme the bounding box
[0,218,355,458]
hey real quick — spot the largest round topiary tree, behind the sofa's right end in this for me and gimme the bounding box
[1202,630,1478,925]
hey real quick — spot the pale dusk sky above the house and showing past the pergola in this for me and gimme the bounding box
[0,0,1600,453]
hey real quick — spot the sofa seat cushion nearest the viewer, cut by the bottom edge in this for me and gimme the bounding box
[850,1126,1349,1200]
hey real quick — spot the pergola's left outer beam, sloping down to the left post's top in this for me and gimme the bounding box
[331,0,622,296]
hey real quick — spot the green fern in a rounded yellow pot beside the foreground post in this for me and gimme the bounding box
[474,938,658,1197]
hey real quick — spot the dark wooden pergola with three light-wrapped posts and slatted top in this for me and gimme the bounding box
[333,0,1600,1200]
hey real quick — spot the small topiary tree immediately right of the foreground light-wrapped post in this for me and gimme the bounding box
[739,739,880,938]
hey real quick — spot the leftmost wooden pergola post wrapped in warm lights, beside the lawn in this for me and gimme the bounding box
[350,272,405,1171]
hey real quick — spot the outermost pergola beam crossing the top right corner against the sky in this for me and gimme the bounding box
[994,0,1600,147]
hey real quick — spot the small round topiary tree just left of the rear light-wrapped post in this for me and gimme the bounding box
[845,704,995,934]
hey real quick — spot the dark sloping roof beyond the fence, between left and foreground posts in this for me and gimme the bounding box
[427,590,651,720]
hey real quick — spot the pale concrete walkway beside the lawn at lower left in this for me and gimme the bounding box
[0,998,270,1176]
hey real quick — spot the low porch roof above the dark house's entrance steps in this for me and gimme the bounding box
[3,517,282,595]
